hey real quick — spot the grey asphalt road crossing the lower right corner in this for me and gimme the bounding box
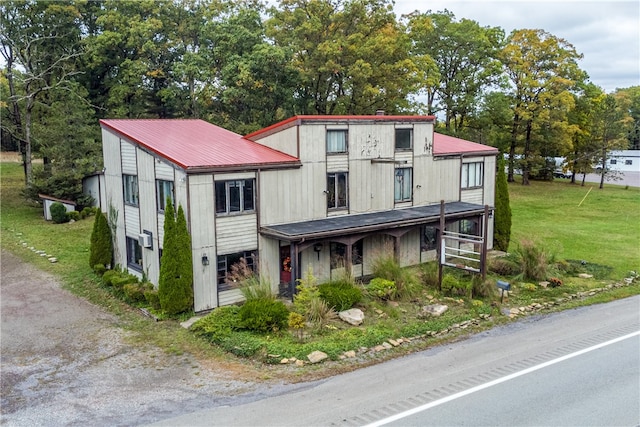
[149,296,640,426]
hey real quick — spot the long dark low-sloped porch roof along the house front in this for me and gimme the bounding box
[260,202,492,241]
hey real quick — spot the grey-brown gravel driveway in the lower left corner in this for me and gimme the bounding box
[0,251,279,426]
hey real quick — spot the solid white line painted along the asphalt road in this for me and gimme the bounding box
[364,331,640,427]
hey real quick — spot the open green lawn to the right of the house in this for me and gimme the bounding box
[509,181,640,278]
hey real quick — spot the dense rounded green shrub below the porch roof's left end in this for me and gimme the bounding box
[238,299,289,333]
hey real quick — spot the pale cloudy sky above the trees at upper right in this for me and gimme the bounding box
[394,0,640,93]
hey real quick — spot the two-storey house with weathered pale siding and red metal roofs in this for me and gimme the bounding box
[100,115,498,312]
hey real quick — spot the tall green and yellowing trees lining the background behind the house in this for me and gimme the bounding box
[0,0,640,200]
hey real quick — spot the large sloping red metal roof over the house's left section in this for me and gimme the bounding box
[100,119,300,170]
